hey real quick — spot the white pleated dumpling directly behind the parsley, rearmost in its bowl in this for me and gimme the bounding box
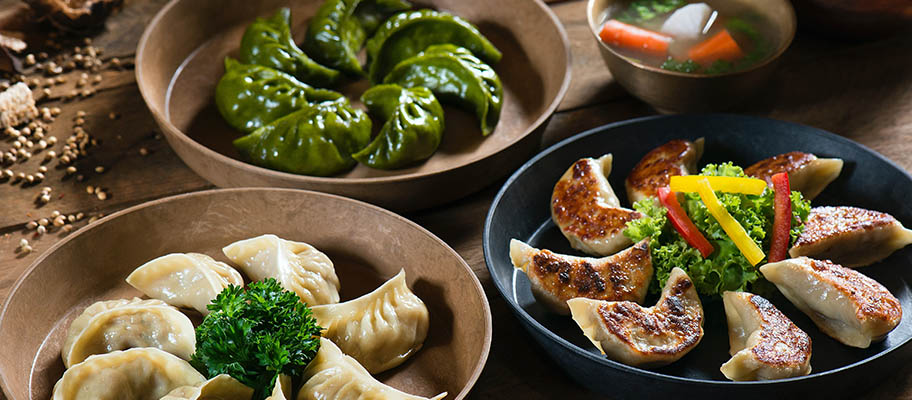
[222,235,339,306]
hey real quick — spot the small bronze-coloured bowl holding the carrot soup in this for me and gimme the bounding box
[586,0,797,112]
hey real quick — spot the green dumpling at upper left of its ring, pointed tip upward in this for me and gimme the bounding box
[241,8,339,87]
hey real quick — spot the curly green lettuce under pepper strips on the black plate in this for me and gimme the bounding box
[624,163,811,296]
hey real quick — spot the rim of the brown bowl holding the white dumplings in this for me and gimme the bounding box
[0,188,493,400]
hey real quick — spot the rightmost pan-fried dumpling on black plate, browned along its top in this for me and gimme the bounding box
[789,207,912,268]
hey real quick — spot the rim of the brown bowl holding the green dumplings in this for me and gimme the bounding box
[135,0,572,185]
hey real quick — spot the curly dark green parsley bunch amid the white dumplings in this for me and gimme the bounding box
[190,278,321,399]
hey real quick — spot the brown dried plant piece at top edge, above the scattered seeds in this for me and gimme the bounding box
[26,0,123,31]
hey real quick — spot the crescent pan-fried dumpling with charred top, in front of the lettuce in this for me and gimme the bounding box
[567,267,703,368]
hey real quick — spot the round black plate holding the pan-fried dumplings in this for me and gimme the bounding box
[484,115,912,399]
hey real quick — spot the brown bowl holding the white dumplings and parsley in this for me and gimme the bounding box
[0,188,491,400]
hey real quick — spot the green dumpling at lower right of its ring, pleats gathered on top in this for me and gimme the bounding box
[352,85,444,169]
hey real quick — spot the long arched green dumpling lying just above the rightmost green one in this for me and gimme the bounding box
[367,10,501,83]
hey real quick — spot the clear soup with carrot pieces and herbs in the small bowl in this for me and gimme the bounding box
[598,0,780,74]
